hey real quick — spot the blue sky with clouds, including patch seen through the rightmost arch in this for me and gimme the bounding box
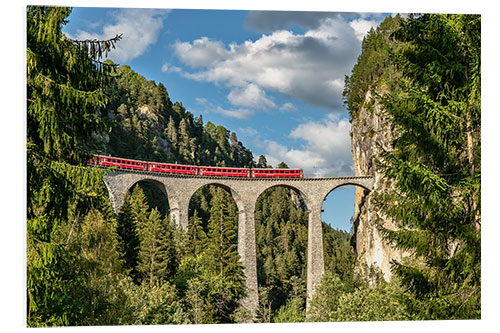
[63,7,389,230]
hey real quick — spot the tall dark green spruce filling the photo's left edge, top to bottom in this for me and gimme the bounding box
[26,6,119,326]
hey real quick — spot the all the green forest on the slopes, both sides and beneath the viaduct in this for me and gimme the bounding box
[26,7,480,327]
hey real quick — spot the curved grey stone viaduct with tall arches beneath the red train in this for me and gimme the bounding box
[104,170,373,316]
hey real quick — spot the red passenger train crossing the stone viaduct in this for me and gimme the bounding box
[89,155,304,178]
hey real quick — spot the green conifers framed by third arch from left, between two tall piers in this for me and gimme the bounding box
[255,187,308,322]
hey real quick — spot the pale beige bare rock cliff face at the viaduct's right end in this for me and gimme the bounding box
[351,91,404,281]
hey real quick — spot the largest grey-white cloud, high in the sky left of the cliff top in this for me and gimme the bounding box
[173,12,380,111]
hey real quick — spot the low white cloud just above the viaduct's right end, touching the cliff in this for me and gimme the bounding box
[265,114,353,177]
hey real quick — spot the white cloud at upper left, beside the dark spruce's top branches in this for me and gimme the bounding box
[70,8,168,63]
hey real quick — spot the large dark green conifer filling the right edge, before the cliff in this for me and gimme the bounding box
[378,15,481,319]
